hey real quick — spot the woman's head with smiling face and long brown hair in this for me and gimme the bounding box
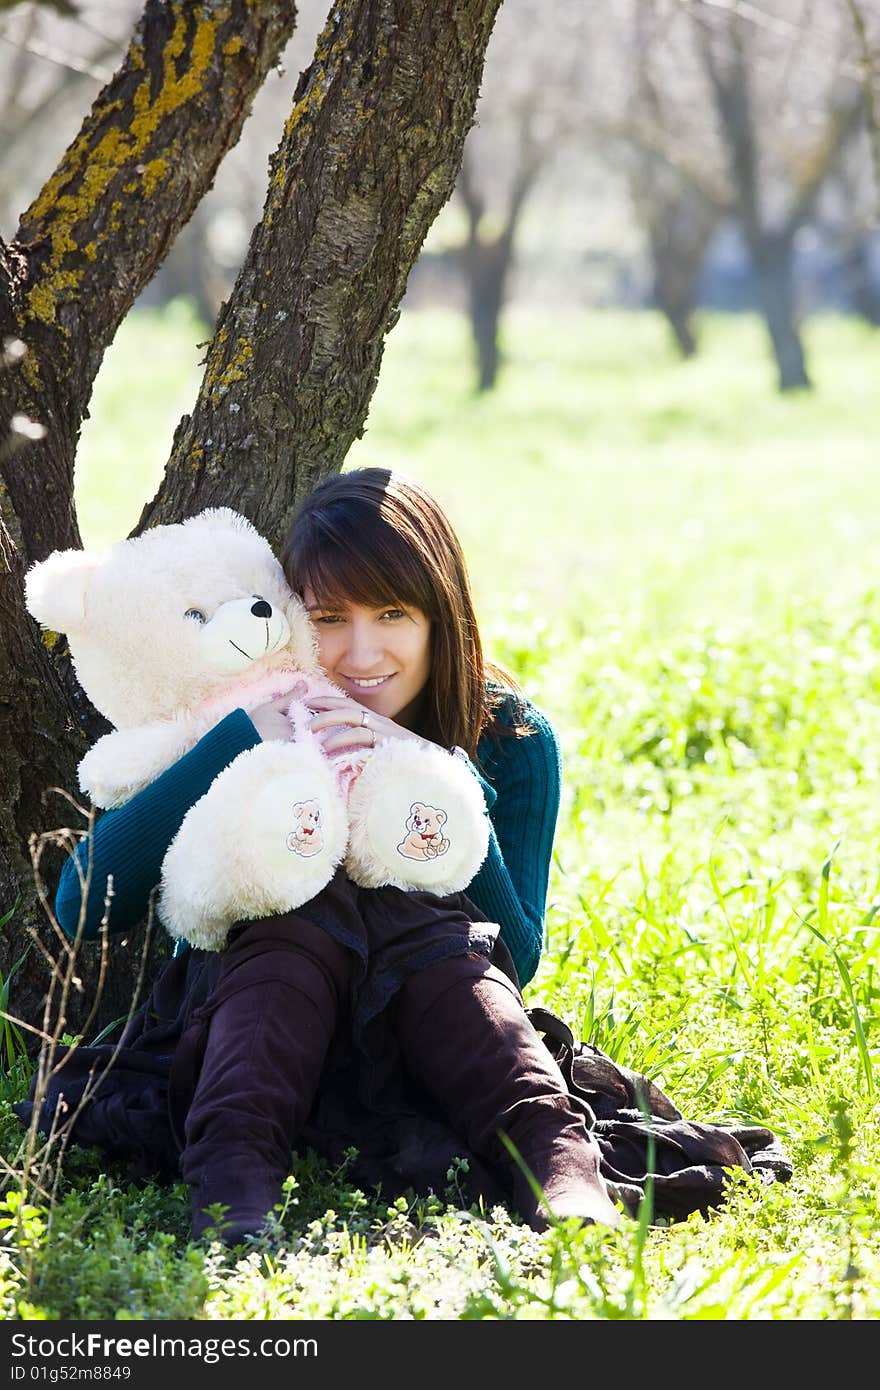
[281,468,508,759]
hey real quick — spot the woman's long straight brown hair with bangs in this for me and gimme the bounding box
[281,468,528,758]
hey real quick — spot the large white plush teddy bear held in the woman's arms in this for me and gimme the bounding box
[25,507,488,949]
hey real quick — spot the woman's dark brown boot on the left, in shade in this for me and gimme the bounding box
[172,913,349,1245]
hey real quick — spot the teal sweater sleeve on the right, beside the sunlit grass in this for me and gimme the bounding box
[467,705,562,987]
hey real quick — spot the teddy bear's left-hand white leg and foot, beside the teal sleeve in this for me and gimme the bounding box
[158,742,348,949]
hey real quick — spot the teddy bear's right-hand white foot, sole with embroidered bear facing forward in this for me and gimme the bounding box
[346,739,489,894]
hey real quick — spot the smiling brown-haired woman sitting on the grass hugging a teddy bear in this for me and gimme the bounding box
[22,468,619,1243]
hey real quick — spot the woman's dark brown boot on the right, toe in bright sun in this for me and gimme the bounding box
[395,955,620,1230]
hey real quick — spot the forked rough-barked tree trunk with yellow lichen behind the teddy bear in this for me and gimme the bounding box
[0,0,500,1029]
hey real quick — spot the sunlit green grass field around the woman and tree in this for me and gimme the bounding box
[0,306,880,1321]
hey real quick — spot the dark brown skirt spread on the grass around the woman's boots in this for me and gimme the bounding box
[15,873,791,1218]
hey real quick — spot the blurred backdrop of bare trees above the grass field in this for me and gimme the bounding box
[0,0,880,389]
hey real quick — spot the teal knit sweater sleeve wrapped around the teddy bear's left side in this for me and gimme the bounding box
[56,709,260,941]
